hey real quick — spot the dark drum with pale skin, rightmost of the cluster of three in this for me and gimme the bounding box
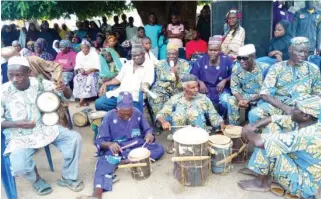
[224,125,248,164]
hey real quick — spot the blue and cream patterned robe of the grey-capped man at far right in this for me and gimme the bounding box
[249,61,321,123]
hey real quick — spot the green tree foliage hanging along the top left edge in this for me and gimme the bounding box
[1,0,132,20]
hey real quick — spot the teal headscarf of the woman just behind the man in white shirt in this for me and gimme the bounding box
[99,48,122,78]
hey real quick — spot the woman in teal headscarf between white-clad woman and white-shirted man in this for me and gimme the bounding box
[98,48,122,90]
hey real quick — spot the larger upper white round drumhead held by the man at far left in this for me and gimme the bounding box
[36,91,60,113]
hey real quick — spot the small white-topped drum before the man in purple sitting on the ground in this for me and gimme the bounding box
[128,147,151,180]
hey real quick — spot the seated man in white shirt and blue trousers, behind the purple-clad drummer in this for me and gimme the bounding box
[95,45,154,111]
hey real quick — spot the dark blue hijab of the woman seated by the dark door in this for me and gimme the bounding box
[267,21,292,60]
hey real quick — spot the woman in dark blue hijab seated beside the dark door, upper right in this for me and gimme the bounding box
[256,21,292,65]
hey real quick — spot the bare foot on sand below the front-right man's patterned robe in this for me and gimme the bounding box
[237,178,270,192]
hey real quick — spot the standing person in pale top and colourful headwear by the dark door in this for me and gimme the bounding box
[222,10,245,59]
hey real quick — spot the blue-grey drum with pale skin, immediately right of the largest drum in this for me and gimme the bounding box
[209,135,233,173]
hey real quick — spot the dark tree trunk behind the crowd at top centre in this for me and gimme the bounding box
[132,1,197,28]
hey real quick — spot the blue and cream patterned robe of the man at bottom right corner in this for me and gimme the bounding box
[248,115,321,198]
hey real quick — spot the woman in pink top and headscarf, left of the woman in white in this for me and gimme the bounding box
[55,40,77,85]
